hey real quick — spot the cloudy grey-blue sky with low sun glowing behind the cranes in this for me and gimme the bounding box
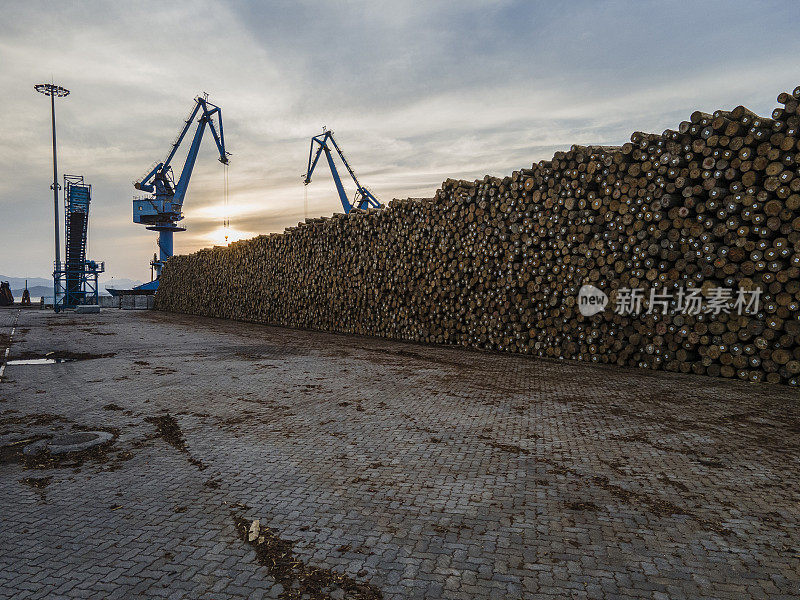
[0,0,800,280]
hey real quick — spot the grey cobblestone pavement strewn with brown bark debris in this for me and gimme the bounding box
[0,309,800,599]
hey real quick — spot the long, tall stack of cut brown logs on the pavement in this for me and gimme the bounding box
[156,87,800,385]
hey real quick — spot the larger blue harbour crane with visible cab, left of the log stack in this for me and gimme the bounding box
[133,95,229,287]
